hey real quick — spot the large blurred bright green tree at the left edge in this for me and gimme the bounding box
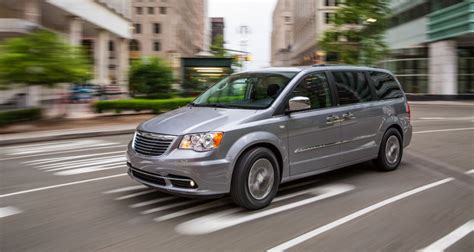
[0,31,91,86]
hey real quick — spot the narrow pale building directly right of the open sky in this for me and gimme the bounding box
[271,0,294,66]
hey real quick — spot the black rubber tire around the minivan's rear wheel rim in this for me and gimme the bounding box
[373,128,403,171]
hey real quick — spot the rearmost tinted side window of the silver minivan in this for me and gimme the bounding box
[369,72,403,100]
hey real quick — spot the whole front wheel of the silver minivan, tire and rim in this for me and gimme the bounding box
[230,147,280,210]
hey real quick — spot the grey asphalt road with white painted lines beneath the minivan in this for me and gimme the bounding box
[0,104,474,252]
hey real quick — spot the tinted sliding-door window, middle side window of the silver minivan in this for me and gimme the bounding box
[332,71,372,105]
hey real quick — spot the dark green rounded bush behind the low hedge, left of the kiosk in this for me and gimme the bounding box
[130,57,174,98]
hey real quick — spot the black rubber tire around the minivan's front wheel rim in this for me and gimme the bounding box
[230,147,280,210]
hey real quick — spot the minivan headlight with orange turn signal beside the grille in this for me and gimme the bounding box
[179,132,224,151]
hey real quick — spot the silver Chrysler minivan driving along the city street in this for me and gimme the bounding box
[127,65,412,209]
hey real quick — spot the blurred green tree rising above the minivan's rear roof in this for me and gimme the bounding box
[319,0,390,65]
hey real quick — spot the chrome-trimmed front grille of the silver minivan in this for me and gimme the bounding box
[133,131,176,156]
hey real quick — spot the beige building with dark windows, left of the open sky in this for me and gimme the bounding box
[130,0,209,77]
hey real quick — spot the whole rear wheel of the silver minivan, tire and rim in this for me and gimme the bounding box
[374,128,403,171]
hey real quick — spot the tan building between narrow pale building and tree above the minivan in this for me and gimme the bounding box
[287,0,340,65]
